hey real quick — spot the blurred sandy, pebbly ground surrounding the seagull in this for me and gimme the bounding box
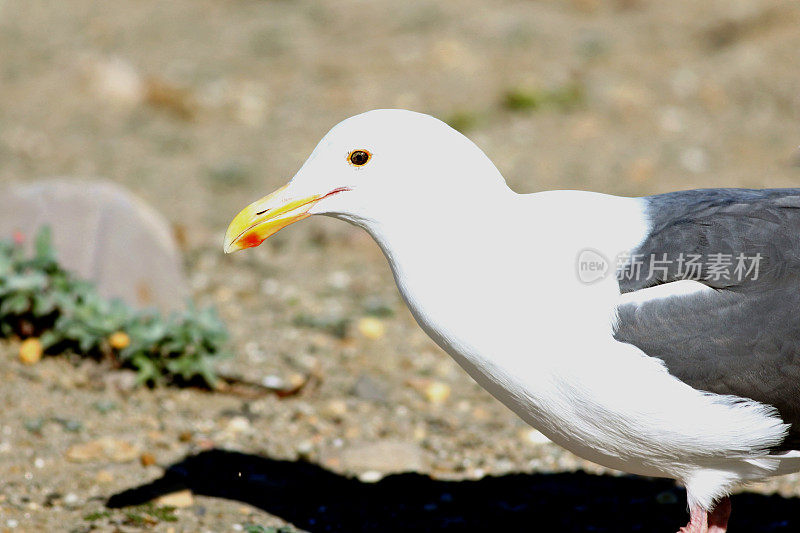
[0,0,800,531]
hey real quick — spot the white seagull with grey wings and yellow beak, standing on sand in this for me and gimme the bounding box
[224,109,800,533]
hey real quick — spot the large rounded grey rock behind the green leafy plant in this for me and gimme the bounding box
[0,179,189,311]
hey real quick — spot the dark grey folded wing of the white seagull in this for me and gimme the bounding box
[615,189,800,449]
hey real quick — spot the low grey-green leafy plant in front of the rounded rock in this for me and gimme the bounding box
[0,228,227,386]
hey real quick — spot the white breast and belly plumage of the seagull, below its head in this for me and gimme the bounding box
[373,192,786,508]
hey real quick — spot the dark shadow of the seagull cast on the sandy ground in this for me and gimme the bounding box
[107,449,800,533]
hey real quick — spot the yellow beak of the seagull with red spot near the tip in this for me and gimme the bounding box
[223,184,325,254]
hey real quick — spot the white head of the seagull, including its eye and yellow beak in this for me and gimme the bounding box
[224,109,510,253]
